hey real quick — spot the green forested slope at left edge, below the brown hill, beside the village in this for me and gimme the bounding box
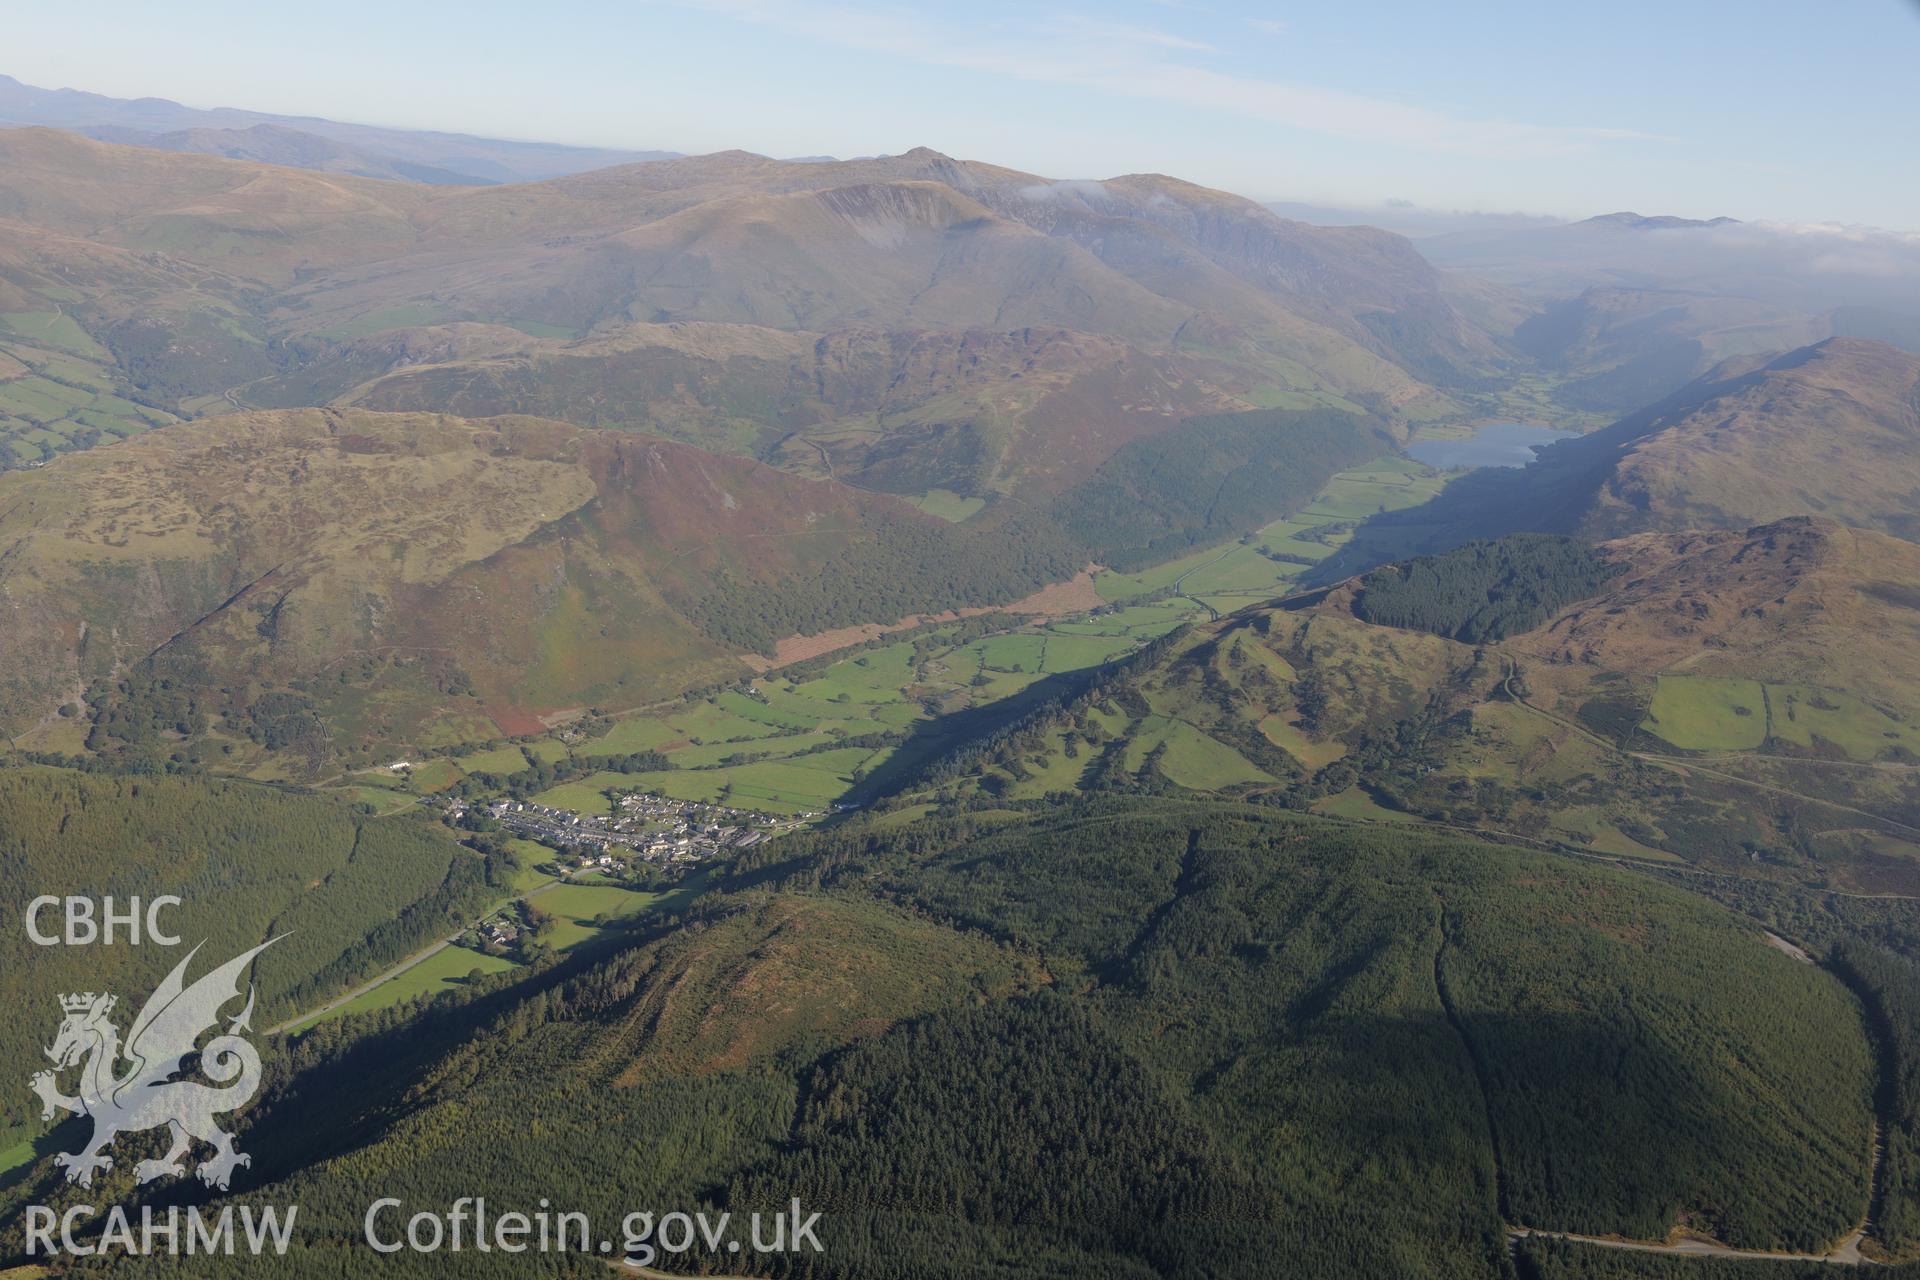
[0,766,507,1128]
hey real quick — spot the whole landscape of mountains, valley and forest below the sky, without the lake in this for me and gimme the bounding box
[0,81,1920,1280]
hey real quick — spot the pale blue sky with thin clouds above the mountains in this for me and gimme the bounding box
[0,0,1920,230]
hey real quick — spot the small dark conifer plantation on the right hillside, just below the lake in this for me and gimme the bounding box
[1354,533,1624,645]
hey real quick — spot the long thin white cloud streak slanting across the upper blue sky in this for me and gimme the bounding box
[670,0,1663,159]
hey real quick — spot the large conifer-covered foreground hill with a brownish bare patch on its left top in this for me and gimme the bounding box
[17,796,1874,1280]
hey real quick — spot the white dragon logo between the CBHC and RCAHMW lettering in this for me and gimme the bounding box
[31,938,280,1192]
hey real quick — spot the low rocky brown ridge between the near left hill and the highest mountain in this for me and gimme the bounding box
[326,322,1246,495]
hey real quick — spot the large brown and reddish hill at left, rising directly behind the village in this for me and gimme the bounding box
[0,411,1081,768]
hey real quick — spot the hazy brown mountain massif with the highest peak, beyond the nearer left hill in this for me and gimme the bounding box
[0,129,1513,497]
